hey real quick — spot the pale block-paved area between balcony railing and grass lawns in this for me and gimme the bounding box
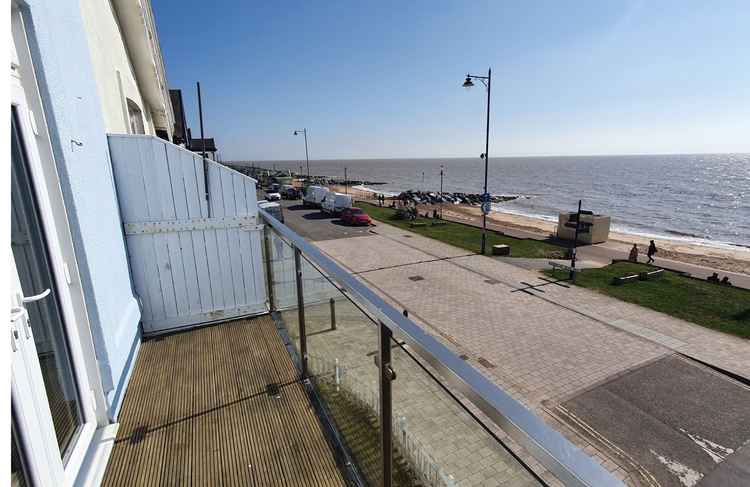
[316,224,750,484]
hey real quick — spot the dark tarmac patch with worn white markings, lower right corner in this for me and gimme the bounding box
[557,355,750,487]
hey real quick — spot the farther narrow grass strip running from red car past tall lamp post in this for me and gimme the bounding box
[357,201,566,259]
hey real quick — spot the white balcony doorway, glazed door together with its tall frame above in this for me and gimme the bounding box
[6,9,97,486]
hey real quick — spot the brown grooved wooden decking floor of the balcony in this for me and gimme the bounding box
[103,317,345,486]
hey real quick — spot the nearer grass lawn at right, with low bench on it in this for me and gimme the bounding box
[546,262,750,338]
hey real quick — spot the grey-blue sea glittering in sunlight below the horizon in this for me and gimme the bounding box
[244,154,750,251]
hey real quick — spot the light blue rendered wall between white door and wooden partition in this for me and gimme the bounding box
[25,0,140,416]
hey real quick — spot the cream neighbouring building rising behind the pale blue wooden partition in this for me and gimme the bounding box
[80,0,175,140]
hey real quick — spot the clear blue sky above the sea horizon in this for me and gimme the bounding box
[152,0,750,160]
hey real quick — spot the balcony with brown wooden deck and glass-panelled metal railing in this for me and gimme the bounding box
[104,211,622,487]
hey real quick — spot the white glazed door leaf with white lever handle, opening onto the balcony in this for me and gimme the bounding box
[9,107,96,485]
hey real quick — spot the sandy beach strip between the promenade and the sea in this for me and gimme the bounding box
[329,185,750,275]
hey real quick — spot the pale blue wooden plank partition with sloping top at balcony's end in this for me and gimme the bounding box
[108,135,268,335]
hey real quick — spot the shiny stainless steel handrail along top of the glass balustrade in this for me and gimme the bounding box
[259,210,624,487]
